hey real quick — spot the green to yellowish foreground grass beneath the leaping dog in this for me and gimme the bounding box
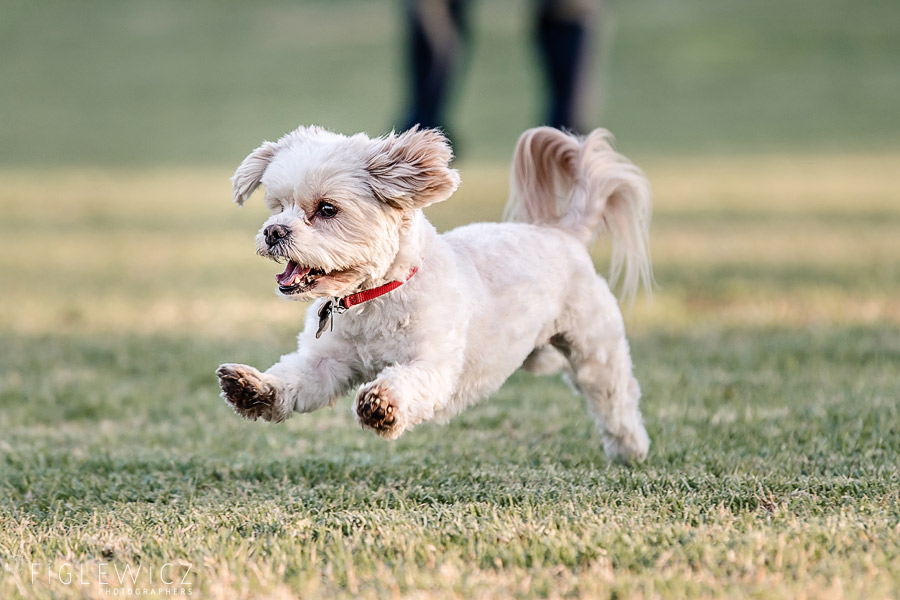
[0,327,900,597]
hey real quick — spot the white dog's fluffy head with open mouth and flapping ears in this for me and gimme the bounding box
[231,127,459,300]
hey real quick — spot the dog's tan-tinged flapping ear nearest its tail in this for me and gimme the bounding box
[366,127,459,209]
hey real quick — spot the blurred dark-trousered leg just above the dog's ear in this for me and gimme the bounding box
[403,0,469,130]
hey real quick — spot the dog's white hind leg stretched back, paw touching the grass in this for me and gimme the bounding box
[550,277,650,462]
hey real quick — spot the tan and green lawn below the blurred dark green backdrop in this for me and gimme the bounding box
[0,161,900,598]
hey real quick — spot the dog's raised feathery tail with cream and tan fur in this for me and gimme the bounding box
[504,127,652,302]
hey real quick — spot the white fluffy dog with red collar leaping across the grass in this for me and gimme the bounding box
[217,127,651,461]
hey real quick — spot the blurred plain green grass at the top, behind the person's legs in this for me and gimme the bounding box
[0,0,900,166]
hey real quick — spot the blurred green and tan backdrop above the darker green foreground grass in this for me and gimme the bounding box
[0,0,900,339]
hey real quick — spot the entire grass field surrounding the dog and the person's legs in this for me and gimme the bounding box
[0,0,900,600]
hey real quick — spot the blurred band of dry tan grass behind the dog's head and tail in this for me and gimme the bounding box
[0,155,900,335]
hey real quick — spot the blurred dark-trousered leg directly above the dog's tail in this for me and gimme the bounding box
[535,0,600,132]
